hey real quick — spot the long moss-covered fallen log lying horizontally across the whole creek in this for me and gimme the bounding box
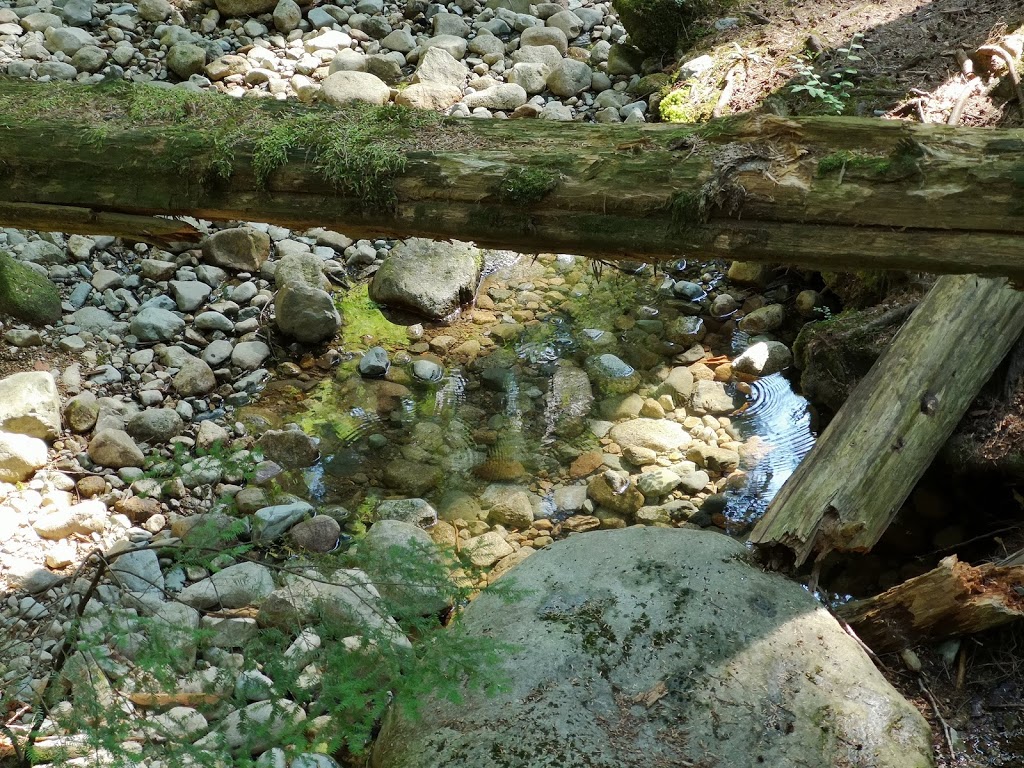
[0,80,1024,279]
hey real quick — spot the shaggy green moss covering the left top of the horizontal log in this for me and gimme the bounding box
[0,83,441,208]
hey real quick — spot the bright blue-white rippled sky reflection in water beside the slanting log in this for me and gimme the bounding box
[726,374,815,522]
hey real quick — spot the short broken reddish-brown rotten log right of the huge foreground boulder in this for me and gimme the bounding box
[837,555,1024,653]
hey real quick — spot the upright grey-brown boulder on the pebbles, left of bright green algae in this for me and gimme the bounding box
[273,253,342,344]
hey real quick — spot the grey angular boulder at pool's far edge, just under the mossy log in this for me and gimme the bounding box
[370,238,483,319]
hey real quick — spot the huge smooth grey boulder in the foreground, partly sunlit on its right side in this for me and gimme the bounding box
[372,527,934,768]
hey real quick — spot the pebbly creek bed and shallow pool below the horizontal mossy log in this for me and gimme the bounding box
[0,214,831,765]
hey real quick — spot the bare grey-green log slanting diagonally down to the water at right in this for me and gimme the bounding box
[750,275,1024,566]
